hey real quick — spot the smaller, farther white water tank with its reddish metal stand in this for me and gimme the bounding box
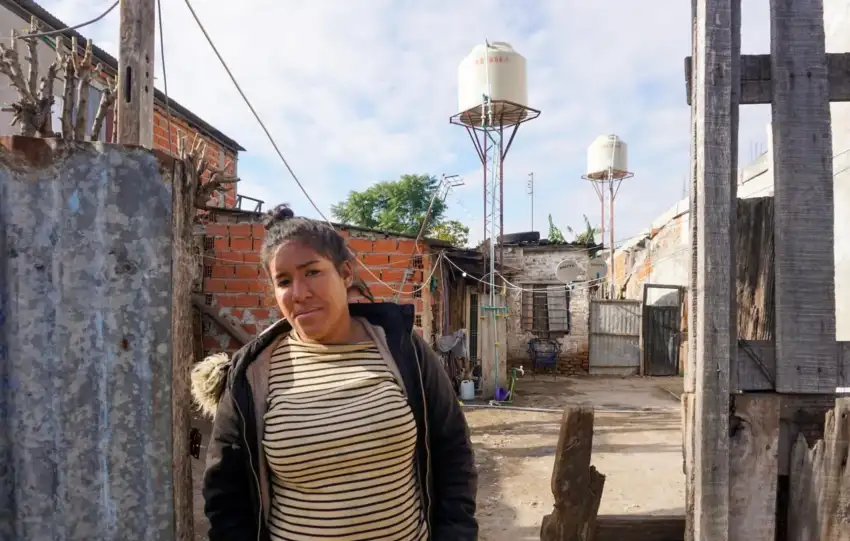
[582,134,634,299]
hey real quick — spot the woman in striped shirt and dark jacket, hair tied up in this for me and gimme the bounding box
[192,205,478,541]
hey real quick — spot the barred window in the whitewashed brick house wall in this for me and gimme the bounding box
[522,284,570,338]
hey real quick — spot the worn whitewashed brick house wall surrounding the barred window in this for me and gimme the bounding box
[505,245,591,374]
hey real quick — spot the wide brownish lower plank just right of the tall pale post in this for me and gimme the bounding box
[729,394,779,541]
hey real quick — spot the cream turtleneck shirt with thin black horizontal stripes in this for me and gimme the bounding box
[263,336,428,541]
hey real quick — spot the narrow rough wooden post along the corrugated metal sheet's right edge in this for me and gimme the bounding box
[165,154,197,541]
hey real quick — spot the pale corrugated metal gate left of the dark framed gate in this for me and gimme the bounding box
[590,299,641,375]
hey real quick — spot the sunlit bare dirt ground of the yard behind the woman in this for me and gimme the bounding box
[187,376,685,541]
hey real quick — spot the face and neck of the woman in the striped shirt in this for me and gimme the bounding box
[269,241,353,342]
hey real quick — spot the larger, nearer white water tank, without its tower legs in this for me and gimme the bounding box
[457,41,528,126]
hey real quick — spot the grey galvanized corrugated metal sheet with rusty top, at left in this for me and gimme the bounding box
[0,138,174,541]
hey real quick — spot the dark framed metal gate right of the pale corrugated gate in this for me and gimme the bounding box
[641,284,684,376]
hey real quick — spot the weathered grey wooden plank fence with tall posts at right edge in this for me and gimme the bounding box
[682,0,850,541]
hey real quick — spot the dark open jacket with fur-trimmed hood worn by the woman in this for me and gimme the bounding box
[192,303,478,541]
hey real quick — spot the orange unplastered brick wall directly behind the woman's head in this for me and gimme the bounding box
[202,217,440,354]
